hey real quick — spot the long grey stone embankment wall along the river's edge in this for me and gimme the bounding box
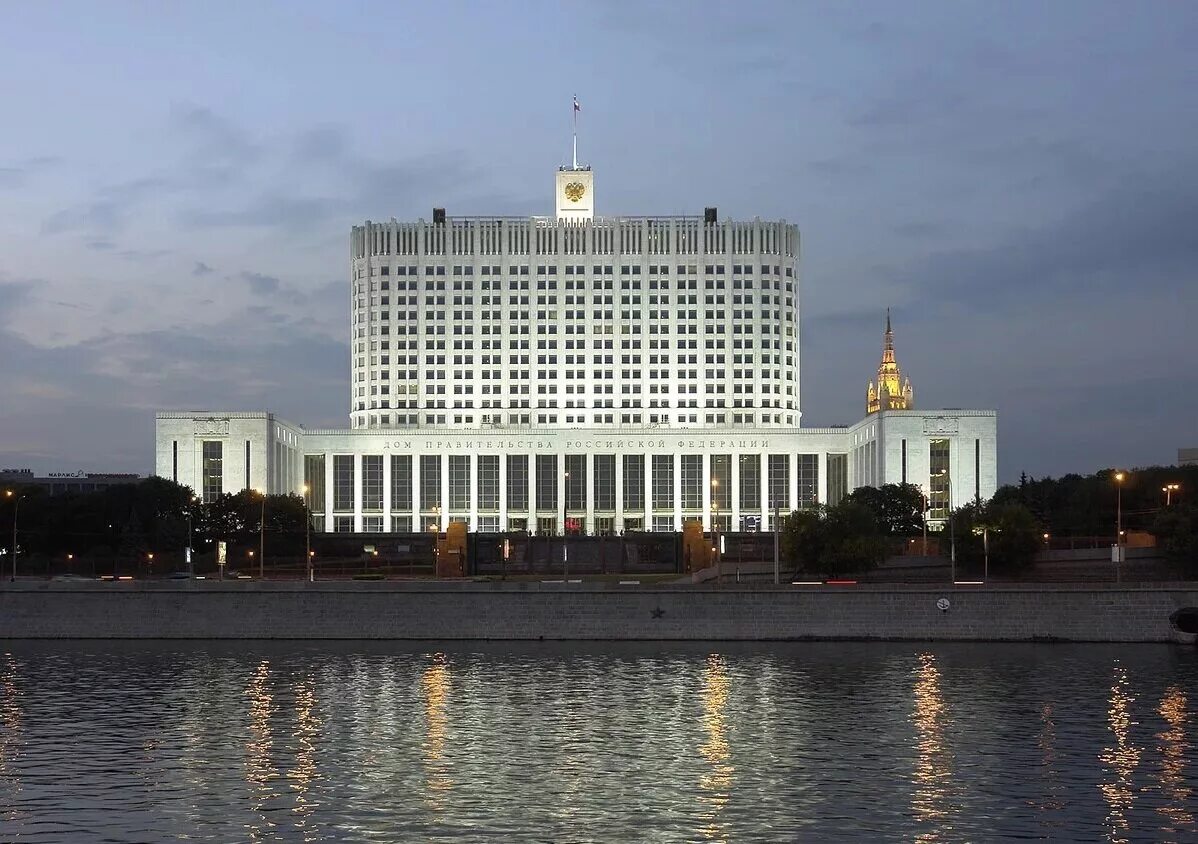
[0,581,1198,643]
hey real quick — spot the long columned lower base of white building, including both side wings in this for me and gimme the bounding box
[157,411,997,533]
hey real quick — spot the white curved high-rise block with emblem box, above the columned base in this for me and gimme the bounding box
[350,159,800,430]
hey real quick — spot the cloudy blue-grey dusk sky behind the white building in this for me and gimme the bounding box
[0,0,1198,482]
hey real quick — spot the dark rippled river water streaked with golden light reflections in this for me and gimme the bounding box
[0,643,1198,844]
